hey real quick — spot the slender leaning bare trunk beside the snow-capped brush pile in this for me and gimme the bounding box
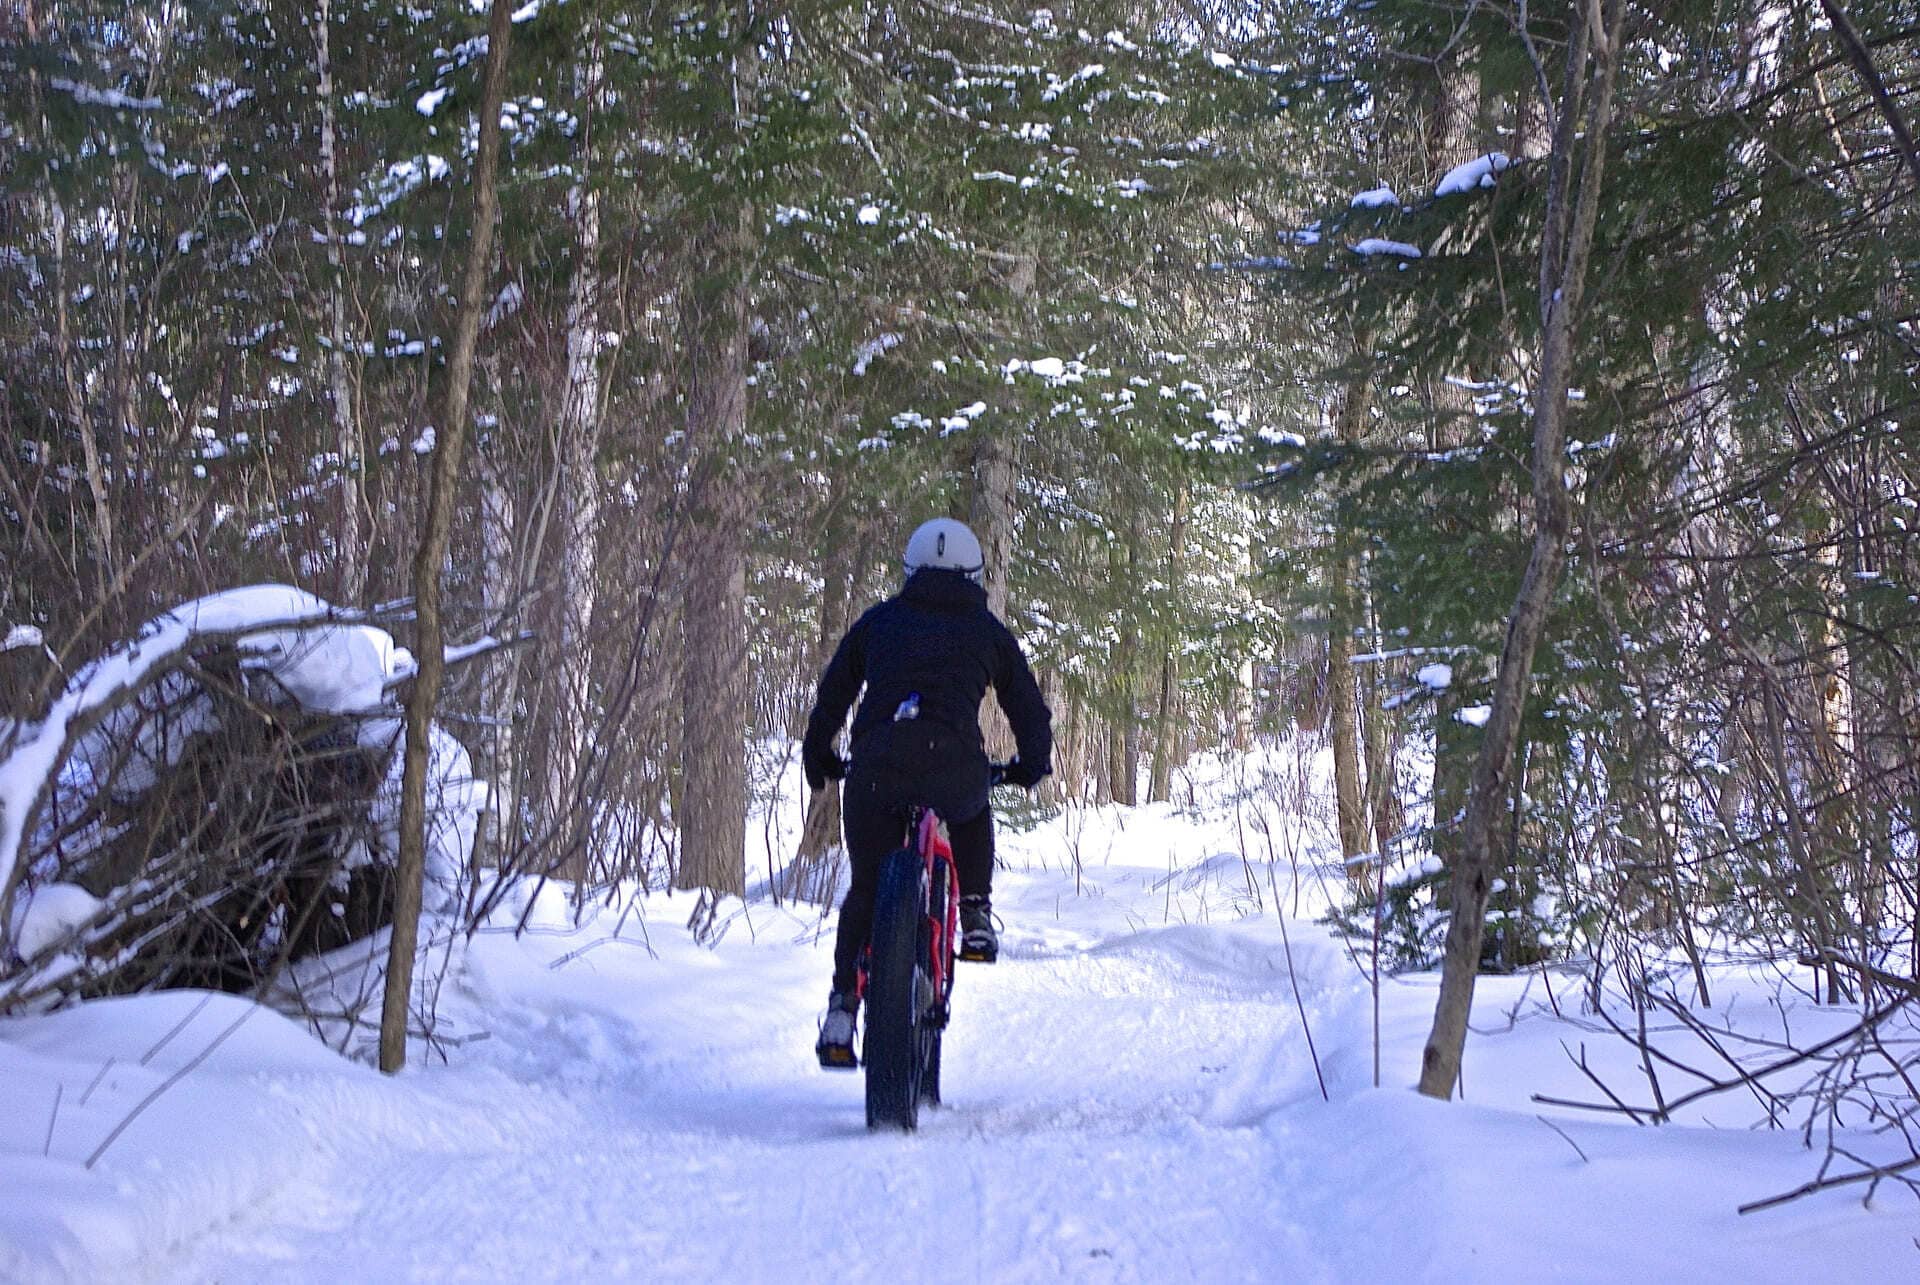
[380,0,513,1074]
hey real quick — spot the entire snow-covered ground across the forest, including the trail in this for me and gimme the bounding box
[0,772,1920,1281]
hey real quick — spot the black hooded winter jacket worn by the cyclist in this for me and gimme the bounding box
[803,569,1054,783]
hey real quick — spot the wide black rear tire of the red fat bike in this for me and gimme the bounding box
[866,849,939,1129]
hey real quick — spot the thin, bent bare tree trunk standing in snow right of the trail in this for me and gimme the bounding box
[1421,0,1626,1099]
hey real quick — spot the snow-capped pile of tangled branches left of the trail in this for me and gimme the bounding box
[0,586,486,1014]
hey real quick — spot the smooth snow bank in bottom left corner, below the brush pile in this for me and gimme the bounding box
[0,991,382,1283]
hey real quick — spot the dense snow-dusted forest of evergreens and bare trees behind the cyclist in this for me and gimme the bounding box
[0,0,1920,1093]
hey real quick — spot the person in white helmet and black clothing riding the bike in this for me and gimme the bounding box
[801,517,1054,1068]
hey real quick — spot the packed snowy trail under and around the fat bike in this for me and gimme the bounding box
[145,860,1338,1281]
